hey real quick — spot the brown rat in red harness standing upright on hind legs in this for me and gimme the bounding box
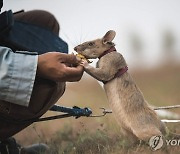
[74,30,166,141]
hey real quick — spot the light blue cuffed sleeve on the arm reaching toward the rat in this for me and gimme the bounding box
[0,46,38,106]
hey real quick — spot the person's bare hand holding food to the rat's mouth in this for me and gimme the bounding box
[37,52,84,82]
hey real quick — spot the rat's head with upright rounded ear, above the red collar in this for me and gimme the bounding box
[74,30,116,59]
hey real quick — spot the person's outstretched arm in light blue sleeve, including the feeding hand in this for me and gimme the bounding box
[0,46,84,106]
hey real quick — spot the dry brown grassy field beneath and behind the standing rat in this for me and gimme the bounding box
[15,65,180,154]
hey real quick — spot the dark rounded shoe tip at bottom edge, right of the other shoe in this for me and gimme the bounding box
[20,143,50,154]
